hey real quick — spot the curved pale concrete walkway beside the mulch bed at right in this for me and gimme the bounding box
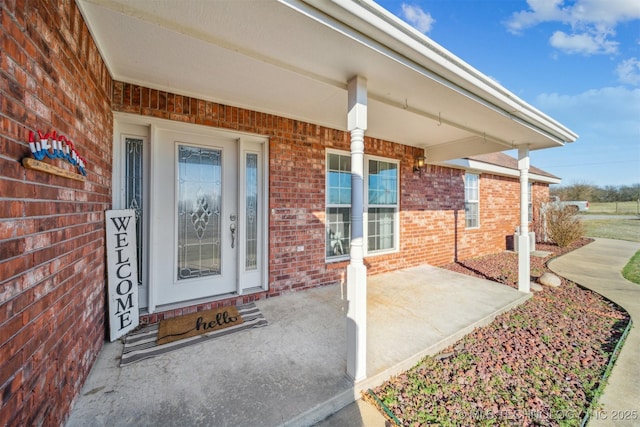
[549,238,640,427]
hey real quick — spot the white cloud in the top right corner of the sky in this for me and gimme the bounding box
[505,0,640,55]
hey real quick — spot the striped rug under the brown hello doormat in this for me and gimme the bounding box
[120,303,269,366]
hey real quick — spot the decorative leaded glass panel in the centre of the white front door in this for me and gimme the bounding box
[177,145,222,280]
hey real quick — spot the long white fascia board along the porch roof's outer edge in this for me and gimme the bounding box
[279,0,578,145]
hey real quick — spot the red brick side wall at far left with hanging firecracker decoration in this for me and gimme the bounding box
[0,0,113,426]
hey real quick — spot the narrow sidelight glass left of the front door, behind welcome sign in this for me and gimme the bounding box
[124,138,144,286]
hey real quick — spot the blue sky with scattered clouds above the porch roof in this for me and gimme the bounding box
[376,0,640,187]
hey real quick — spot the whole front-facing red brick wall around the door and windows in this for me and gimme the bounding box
[113,82,548,310]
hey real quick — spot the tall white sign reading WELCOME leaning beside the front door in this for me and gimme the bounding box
[105,209,139,341]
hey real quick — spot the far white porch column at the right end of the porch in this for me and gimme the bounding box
[518,146,531,292]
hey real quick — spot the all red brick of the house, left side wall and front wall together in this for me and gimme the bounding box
[0,0,548,425]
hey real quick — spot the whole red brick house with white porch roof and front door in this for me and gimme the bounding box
[0,0,577,425]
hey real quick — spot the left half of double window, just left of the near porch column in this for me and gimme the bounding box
[325,152,351,260]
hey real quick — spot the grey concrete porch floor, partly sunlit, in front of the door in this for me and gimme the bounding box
[67,266,531,427]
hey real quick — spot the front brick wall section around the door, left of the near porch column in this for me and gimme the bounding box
[113,82,358,304]
